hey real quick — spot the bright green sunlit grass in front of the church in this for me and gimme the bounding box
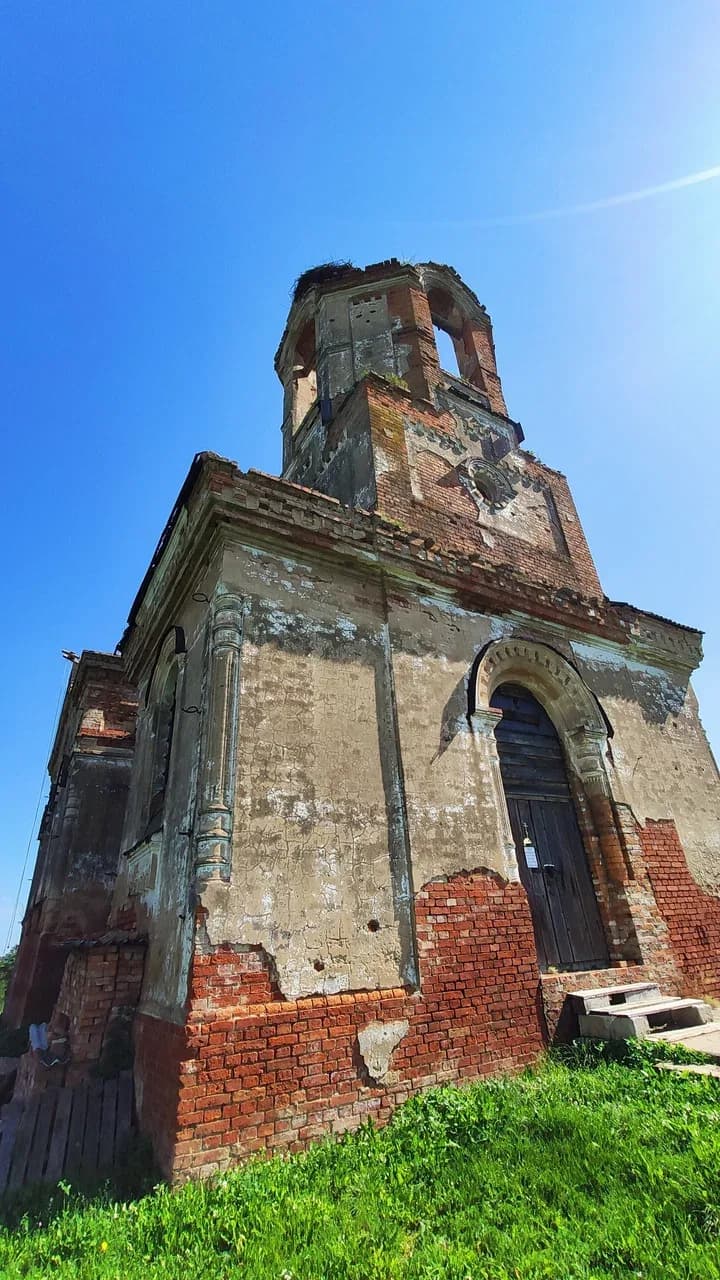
[0,1050,720,1280]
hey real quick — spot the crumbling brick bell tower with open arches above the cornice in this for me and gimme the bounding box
[275,259,602,598]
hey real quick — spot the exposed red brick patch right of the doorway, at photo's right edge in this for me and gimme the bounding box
[639,822,720,998]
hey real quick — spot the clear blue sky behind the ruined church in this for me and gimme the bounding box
[0,0,720,950]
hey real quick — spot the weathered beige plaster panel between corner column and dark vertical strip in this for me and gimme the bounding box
[202,548,414,997]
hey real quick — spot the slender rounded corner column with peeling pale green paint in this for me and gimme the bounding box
[195,594,242,881]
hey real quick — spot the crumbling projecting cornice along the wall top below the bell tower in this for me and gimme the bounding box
[116,454,700,678]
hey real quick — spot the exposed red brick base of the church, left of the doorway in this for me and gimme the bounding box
[141,872,544,1176]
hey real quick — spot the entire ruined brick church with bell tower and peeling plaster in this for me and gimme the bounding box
[10,260,720,1178]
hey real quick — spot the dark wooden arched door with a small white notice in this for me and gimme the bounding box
[491,684,609,970]
